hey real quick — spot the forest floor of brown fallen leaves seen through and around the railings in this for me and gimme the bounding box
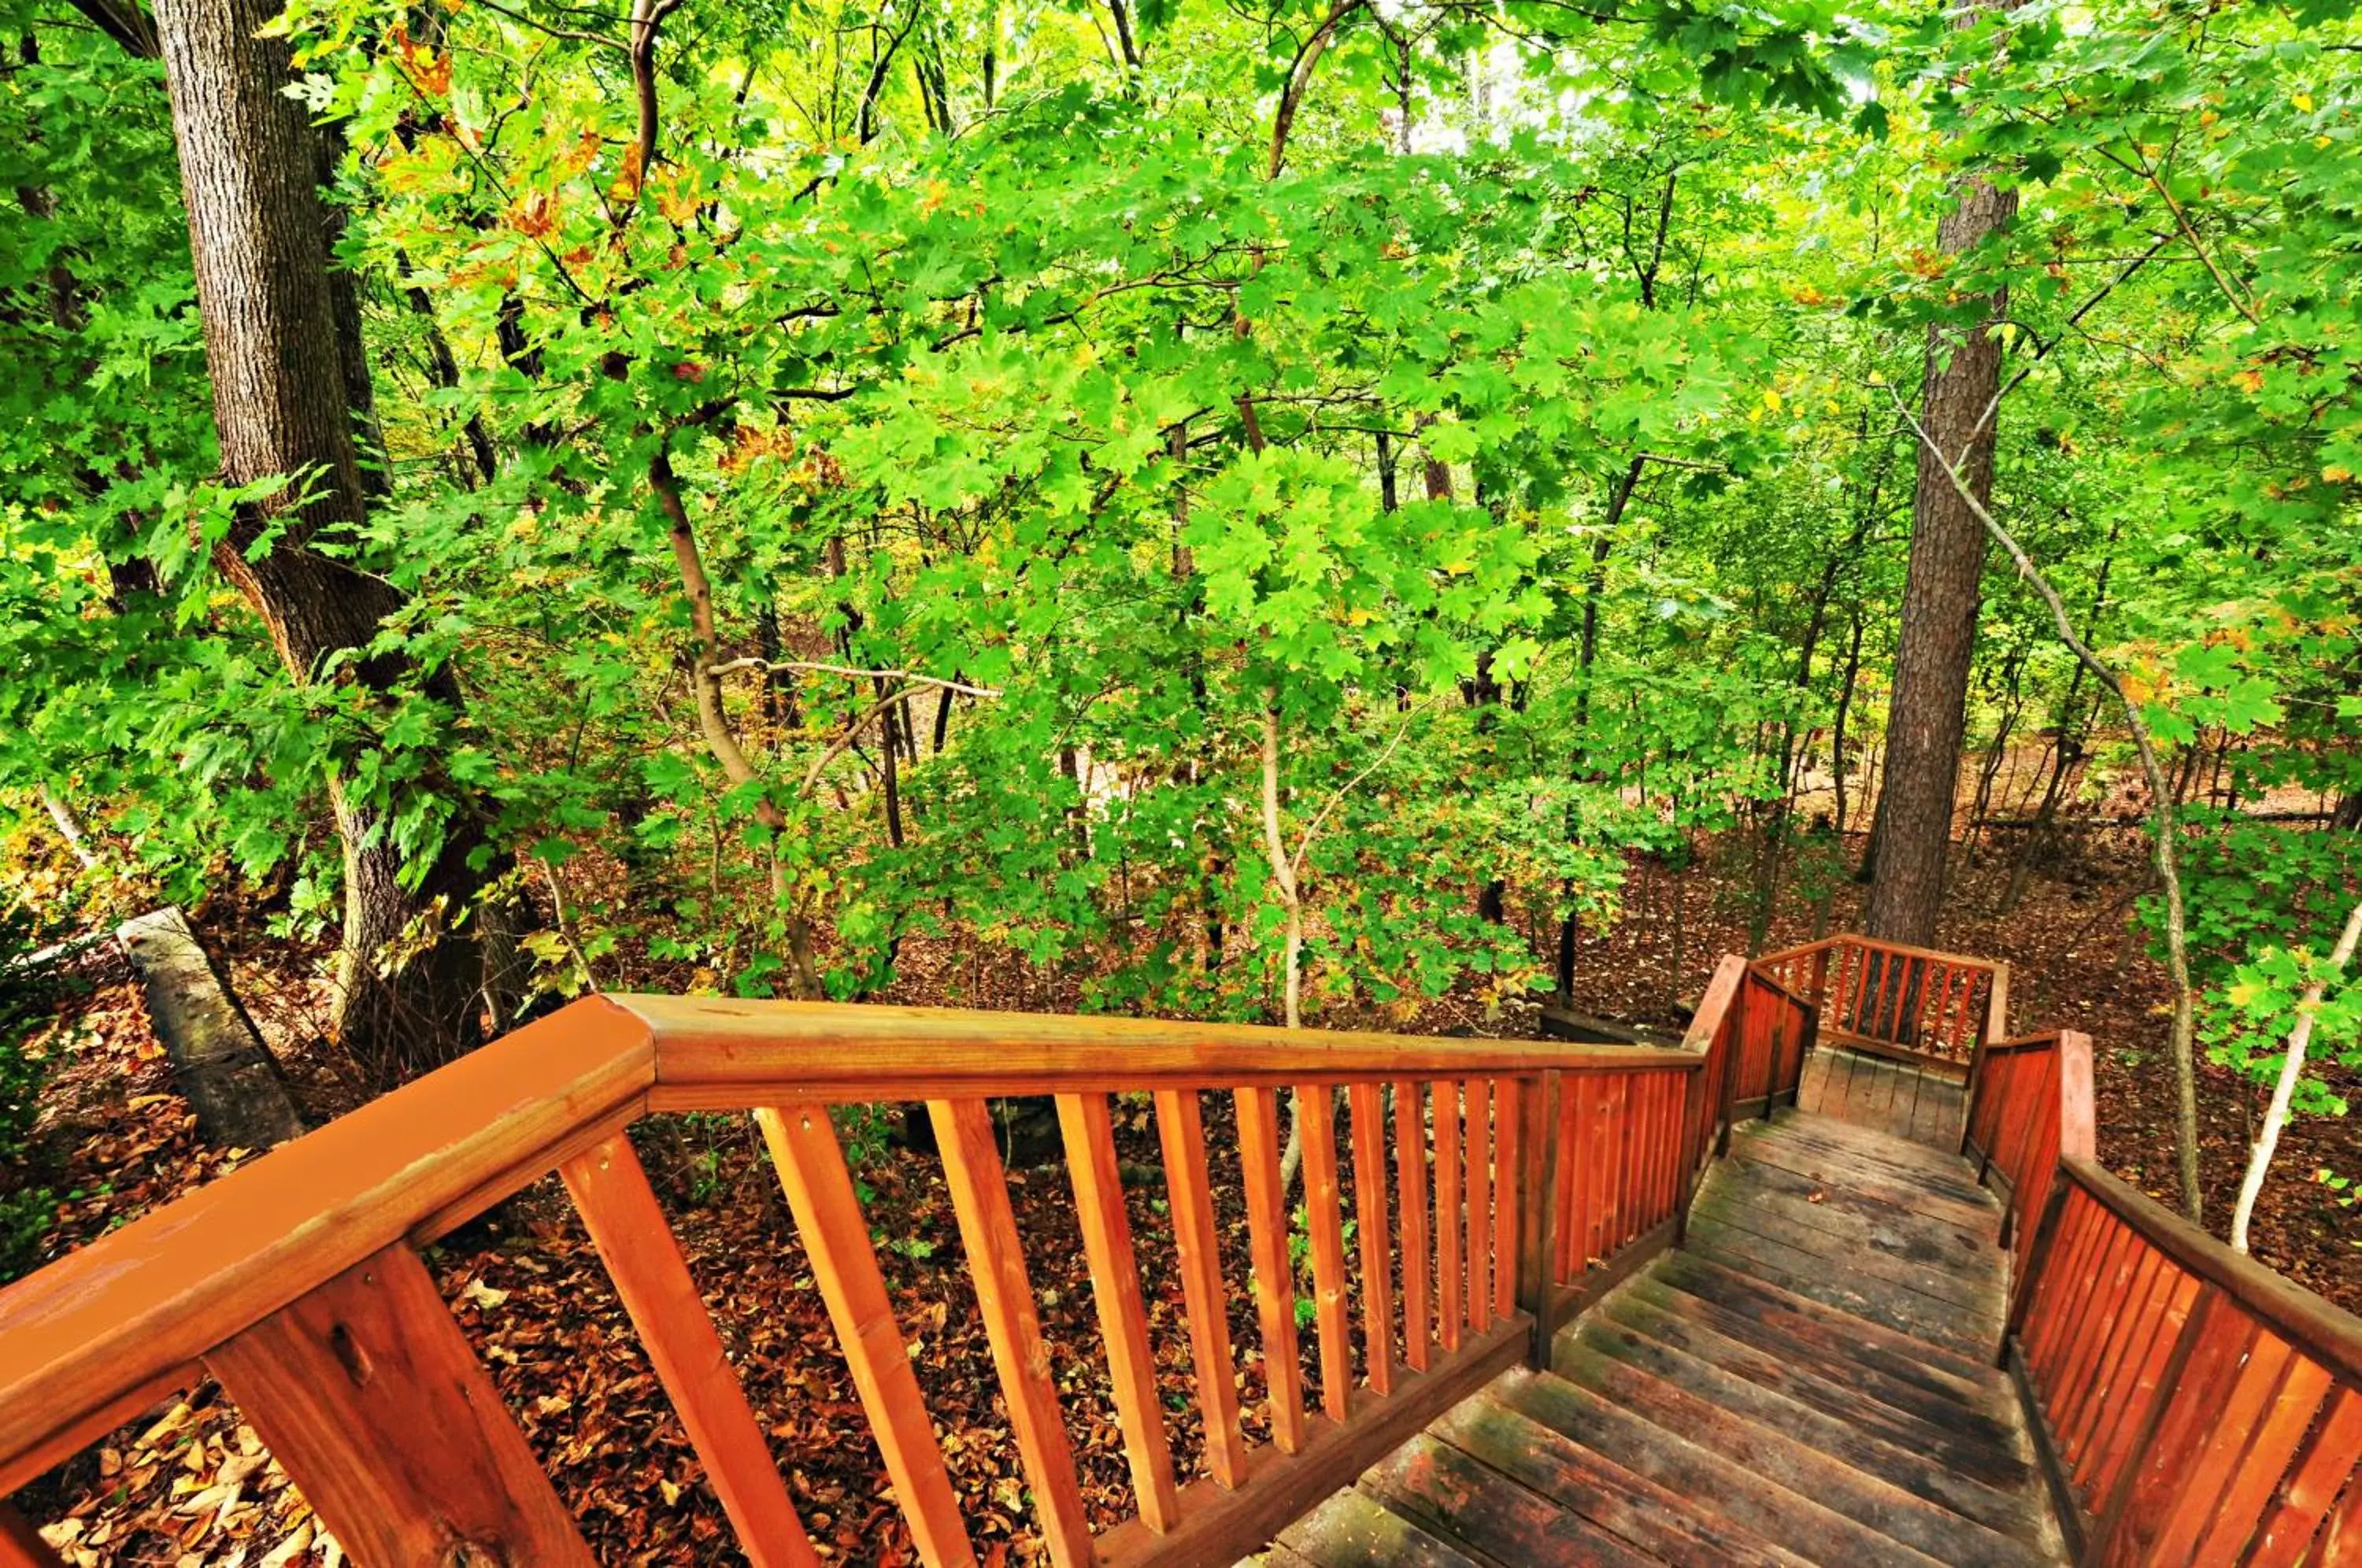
[17,831,2362,1568]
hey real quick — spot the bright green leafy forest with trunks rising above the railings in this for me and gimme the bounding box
[0,0,2362,1247]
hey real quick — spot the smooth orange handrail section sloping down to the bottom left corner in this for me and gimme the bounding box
[0,999,654,1492]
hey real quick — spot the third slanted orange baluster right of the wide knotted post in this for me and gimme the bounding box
[926,1100,1094,1568]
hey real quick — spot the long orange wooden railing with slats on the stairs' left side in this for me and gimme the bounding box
[0,959,1814,1568]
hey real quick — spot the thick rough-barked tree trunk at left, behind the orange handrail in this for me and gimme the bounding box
[156,0,515,1084]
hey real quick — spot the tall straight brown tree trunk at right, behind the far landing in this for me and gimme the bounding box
[1864,135,2017,947]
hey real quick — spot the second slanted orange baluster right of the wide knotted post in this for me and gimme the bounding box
[753,1105,976,1568]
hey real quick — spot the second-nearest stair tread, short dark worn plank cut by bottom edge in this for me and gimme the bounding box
[1361,1433,1658,1568]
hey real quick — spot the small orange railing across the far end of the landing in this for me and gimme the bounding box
[1755,933,2010,1072]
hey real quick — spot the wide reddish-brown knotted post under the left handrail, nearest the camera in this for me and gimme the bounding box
[205,1242,593,1568]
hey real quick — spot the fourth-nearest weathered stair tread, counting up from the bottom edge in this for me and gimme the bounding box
[1493,1372,1937,1568]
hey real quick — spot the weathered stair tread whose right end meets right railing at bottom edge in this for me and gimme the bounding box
[1554,1339,2043,1568]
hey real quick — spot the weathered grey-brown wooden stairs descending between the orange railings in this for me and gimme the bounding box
[1264,1112,2064,1568]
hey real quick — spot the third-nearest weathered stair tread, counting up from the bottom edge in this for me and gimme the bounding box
[1429,1391,1807,1568]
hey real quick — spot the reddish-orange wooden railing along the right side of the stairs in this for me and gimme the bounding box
[1968,1030,2362,1566]
